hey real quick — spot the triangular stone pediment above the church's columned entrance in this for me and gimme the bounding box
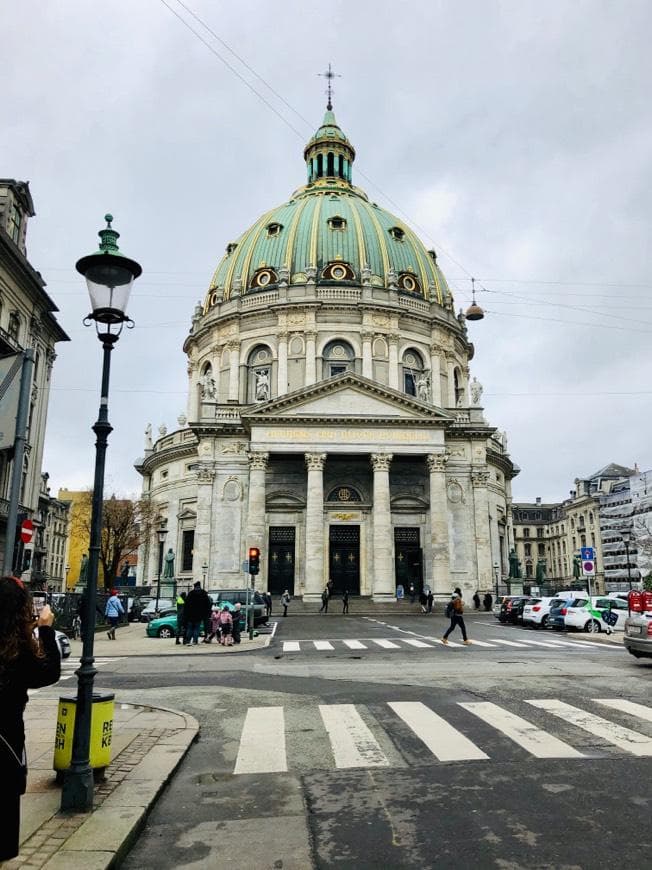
[242,372,451,423]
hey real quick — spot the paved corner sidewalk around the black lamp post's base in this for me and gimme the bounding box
[0,700,199,870]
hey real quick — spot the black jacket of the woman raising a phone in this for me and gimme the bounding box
[0,625,61,789]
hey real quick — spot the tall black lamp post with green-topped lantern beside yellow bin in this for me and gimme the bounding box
[61,214,142,812]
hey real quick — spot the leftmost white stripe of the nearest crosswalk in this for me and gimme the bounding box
[233,707,288,773]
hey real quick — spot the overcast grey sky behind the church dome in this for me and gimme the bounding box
[0,0,652,501]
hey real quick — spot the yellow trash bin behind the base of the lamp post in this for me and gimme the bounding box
[53,693,115,771]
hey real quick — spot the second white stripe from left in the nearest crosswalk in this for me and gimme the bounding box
[319,704,389,768]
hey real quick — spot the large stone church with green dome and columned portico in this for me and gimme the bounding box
[136,100,518,600]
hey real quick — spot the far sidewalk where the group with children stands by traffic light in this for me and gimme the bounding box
[67,622,274,661]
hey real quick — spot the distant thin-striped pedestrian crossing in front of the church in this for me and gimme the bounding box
[282,635,622,653]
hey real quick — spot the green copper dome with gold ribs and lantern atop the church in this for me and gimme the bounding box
[204,108,452,310]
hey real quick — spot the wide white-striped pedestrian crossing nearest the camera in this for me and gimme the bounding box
[233,698,652,775]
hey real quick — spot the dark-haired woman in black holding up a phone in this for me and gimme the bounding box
[0,577,61,861]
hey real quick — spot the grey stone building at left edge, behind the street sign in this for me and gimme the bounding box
[0,178,68,581]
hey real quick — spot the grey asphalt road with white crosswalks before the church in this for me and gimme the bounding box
[56,613,652,870]
